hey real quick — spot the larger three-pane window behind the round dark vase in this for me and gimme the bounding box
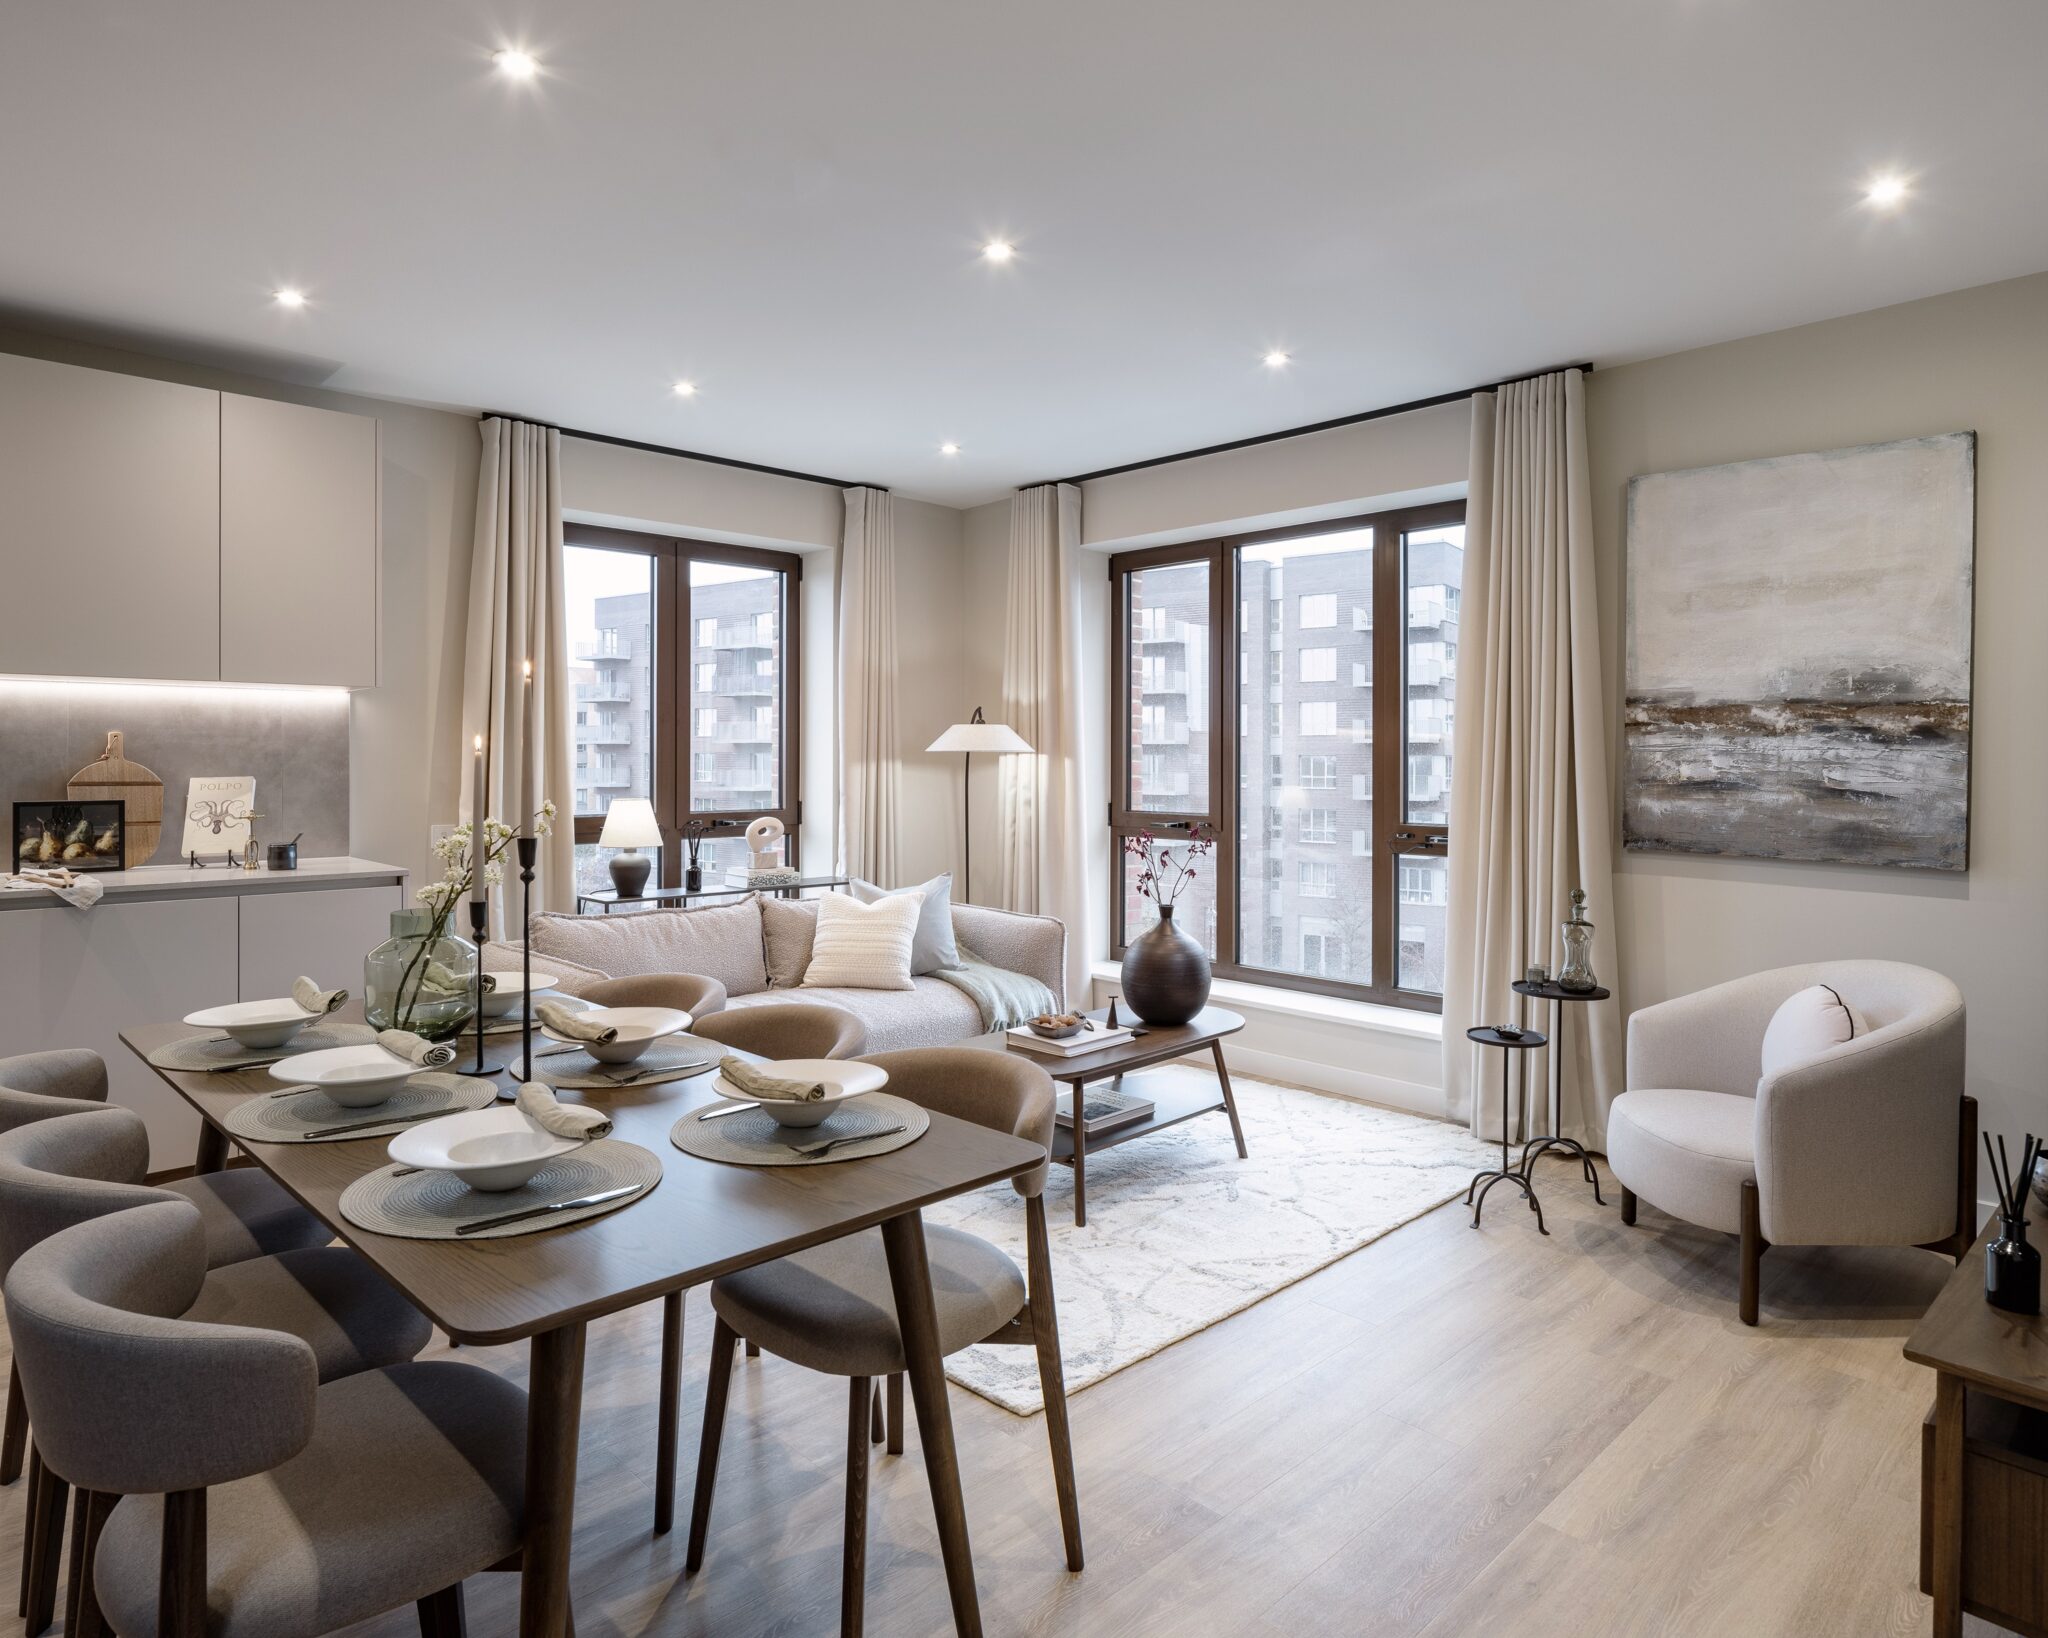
[1110,504,1464,1009]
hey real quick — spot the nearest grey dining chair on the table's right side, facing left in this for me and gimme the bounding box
[684,1046,1081,1638]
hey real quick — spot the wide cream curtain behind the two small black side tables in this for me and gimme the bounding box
[1444,371,1622,1149]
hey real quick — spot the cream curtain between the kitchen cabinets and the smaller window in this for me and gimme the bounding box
[457,416,575,938]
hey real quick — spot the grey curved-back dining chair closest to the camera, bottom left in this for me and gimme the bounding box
[6,1200,526,1638]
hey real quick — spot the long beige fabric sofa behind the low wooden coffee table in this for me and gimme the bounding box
[485,897,1067,1052]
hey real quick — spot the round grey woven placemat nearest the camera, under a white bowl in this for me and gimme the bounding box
[340,1138,662,1241]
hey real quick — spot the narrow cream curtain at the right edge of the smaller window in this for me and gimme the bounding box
[838,489,901,887]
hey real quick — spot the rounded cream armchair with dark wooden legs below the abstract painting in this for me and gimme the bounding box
[1608,960,1976,1325]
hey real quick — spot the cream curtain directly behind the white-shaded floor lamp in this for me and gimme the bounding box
[995,483,1100,1001]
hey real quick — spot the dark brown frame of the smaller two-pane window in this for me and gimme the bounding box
[577,524,803,887]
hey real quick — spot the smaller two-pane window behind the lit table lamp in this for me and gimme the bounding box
[563,524,803,891]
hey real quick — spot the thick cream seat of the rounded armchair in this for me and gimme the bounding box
[1608,1089,1757,1235]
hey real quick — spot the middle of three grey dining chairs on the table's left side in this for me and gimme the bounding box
[0,1108,432,1638]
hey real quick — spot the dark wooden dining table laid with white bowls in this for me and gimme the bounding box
[121,1001,1044,1638]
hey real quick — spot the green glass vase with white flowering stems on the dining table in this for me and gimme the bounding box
[362,801,555,1040]
